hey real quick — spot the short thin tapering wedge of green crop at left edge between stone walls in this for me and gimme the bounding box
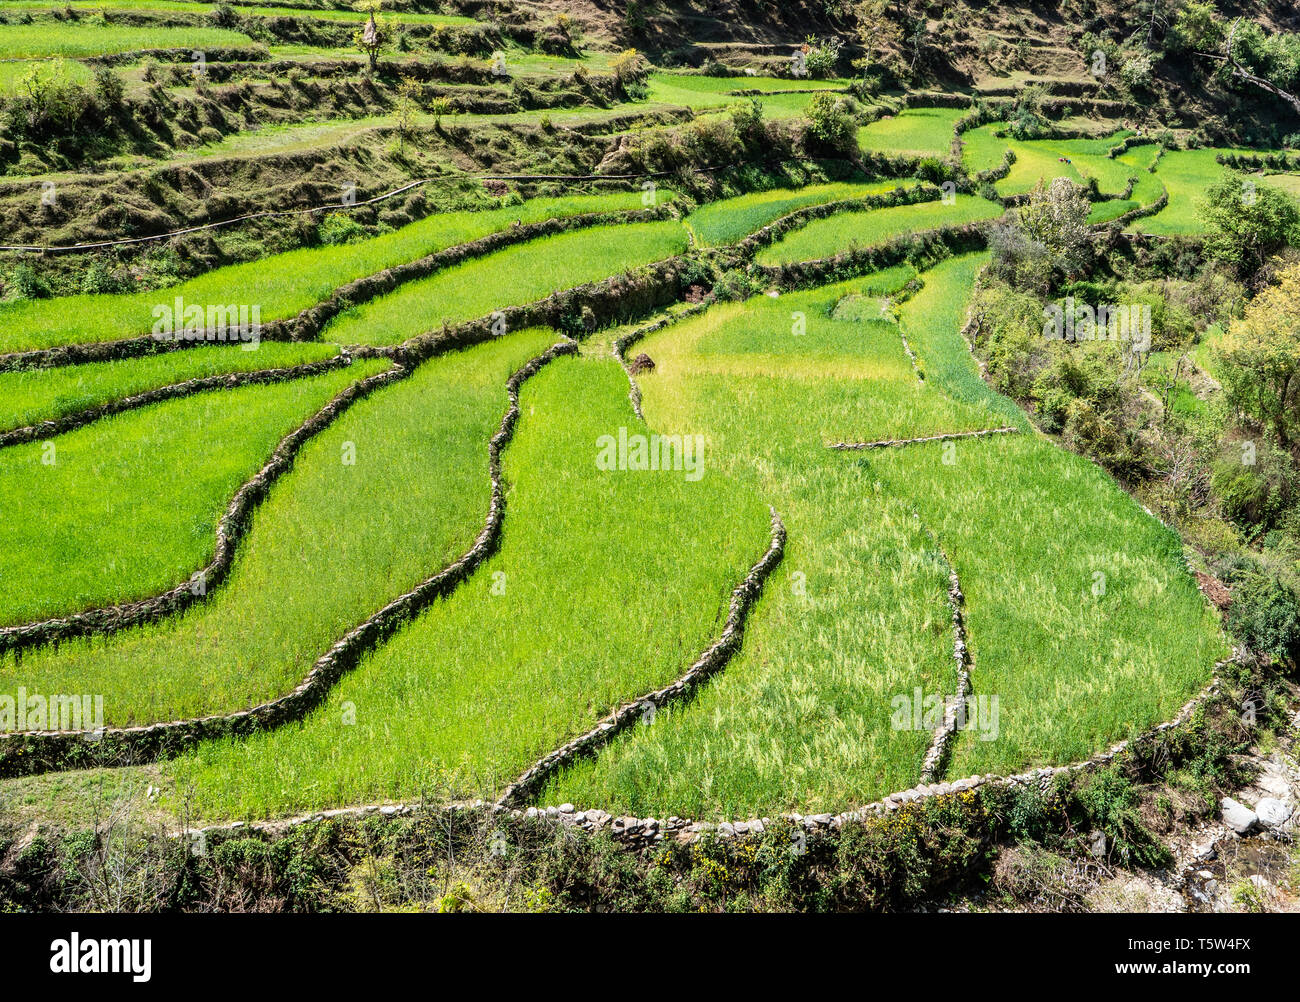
[0,340,338,431]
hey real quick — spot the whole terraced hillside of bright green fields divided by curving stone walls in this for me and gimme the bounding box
[0,9,1268,836]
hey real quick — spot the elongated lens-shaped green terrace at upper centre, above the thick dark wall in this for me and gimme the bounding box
[324,220,686,344]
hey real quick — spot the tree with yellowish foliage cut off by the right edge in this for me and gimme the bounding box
[1218,264,1300,448]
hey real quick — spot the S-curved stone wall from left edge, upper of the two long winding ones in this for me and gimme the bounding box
[0,366,411,652]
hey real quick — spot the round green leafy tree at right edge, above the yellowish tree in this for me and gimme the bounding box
[1201,170,1300,282]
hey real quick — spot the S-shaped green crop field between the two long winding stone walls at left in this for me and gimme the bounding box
[0,331,554,725]
